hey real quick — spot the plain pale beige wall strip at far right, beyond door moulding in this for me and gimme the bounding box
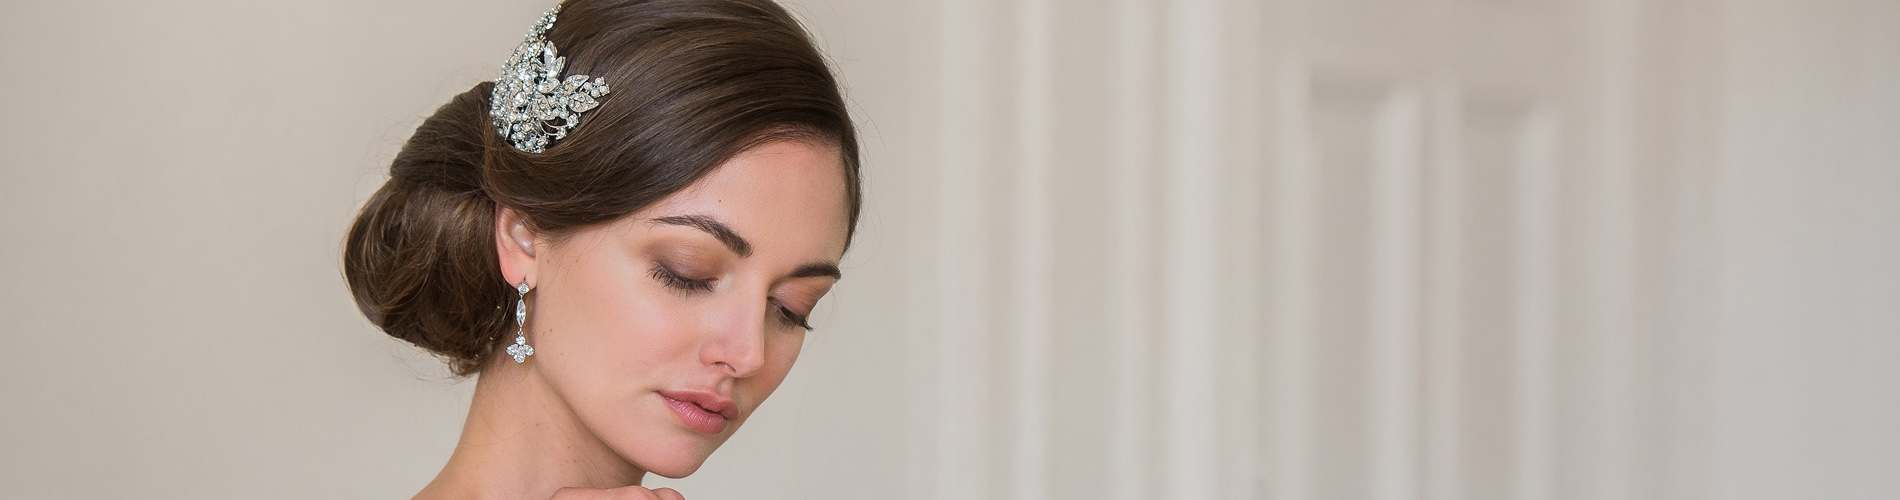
[1708,2,1900,498]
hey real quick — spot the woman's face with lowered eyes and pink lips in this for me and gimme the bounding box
[528,141,847,477]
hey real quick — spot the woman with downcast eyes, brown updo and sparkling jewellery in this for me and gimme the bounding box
[344,0,859,498]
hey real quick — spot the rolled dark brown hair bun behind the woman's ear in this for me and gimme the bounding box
[342,82,511,375]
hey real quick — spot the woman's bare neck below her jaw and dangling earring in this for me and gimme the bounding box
[416,356,646,498]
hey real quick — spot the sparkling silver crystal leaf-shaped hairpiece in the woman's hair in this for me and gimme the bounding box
[488,6,606,152]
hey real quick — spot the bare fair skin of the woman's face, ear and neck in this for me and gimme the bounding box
[416,141,849,500]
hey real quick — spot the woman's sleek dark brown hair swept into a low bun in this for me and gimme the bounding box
[342,0,861,375]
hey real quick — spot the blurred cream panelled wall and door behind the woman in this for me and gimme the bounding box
[0,0,1900,500]
